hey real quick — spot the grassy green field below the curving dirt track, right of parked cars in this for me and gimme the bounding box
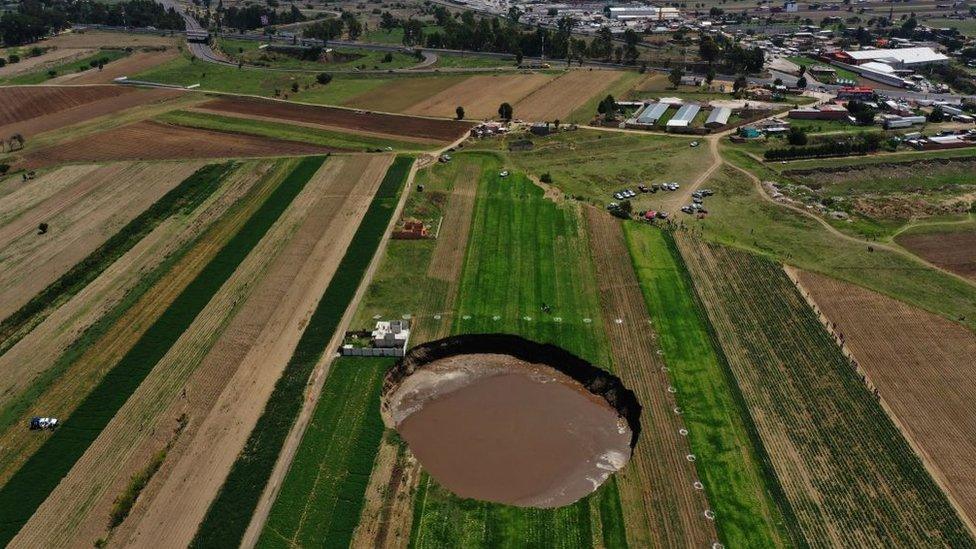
[708,155,976,329]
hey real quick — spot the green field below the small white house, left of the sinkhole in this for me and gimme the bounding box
[258,358,393,548]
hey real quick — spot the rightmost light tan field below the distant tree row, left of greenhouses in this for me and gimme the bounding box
[514,70,623,120]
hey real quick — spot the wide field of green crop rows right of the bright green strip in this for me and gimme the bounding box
[679,236,976,547]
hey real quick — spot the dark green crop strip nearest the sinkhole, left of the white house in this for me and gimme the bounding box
[191,156,413,547]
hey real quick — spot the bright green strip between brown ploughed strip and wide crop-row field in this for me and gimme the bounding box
[624,223,795,547]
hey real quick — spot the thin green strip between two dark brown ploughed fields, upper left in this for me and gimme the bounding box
[156,111,433,151]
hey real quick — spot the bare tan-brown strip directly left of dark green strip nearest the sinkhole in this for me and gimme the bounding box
[120,156,392,547]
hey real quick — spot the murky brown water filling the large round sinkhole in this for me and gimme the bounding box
[392,354,631,507]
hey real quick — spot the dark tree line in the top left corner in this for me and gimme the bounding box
[0,0,185,47]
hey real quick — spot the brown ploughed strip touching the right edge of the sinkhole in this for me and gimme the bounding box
[586,207,718,547]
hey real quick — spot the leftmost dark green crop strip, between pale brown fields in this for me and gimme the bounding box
[0,159,233,353]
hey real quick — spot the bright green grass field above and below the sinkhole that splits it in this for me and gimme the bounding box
[411,157,625,547]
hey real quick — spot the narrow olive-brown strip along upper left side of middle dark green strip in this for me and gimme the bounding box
[0,159,284,488]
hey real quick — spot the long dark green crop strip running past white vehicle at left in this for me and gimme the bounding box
[0,157,325,545]
